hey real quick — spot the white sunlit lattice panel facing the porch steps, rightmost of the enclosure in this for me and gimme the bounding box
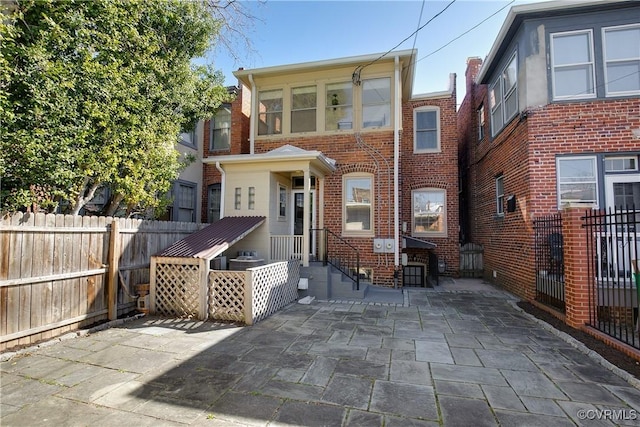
[252,260,300,322]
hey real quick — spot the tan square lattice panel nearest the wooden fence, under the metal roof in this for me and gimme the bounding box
[155,264,200,317]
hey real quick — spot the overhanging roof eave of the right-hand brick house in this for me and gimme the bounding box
[476,0,637,84]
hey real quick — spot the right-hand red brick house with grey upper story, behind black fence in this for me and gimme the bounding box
[458,1,640,304]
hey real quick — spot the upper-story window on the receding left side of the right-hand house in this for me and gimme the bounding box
[489,54,518,136]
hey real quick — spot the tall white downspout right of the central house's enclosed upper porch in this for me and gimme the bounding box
[393,56,402,288]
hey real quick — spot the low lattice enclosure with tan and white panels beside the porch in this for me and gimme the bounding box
[151,257,300,325]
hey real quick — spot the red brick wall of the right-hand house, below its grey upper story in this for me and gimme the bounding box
[459,56,640,299]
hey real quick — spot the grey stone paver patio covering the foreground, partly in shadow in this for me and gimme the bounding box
[0,284,640,427]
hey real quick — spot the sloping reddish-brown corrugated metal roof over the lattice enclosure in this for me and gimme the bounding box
[156,216,266,259]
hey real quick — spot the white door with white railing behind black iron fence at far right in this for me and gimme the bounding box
[598,173,640,281]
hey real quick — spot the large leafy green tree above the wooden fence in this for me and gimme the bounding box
[0,0,235,214]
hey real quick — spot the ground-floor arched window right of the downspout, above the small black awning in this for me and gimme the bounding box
[411,188,447,236]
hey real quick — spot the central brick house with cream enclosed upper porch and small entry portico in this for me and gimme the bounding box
[202,50,459,287]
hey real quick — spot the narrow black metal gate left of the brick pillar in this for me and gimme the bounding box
[533,214,565,313]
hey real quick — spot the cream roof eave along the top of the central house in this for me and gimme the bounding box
[233,49,417,99]
